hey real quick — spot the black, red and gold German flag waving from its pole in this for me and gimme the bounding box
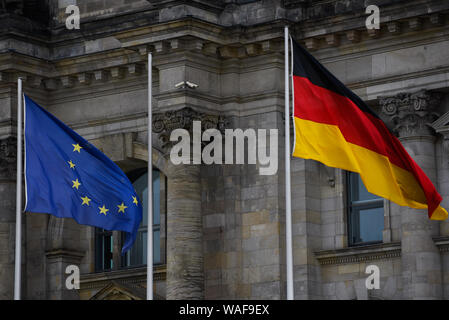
[292,40,448,220]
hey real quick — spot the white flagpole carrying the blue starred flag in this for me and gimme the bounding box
[14,78,22,300]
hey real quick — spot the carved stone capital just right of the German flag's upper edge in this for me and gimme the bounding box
[380,91,442,138]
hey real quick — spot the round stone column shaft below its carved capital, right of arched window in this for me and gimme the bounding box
[167,165,204,300]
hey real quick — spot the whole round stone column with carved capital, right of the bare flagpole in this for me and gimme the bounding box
[153,108,222,300]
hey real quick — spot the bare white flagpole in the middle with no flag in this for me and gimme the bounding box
[147,53,153,300]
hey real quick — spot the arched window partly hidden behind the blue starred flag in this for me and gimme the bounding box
[95,169,166,272]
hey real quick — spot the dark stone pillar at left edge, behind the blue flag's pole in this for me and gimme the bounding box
[0,137,19,300]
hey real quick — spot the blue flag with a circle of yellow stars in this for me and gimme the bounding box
[25,96,142,254]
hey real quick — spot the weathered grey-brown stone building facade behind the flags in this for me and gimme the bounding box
[0,0,449,299]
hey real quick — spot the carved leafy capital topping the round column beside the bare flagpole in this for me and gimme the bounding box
[152,107,226,154]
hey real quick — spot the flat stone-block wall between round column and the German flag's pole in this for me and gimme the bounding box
[202,112,284,299]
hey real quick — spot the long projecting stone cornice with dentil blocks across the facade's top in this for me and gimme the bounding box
[0,1,449,95]
